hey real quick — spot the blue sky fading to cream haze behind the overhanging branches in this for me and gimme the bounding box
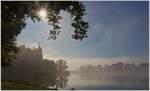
[17,1,149,70]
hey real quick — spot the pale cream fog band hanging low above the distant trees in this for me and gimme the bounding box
[44,57,148,71]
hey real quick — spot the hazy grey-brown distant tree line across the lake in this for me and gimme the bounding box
[80,62,149,74]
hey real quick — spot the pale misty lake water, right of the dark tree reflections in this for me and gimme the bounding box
[65,73,149,90]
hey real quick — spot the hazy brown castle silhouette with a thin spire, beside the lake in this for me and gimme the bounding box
[2,45,43,83]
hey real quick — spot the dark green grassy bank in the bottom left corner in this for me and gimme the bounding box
[1,81,48,90]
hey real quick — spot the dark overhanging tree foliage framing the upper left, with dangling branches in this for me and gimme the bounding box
[1,1,88,67]
